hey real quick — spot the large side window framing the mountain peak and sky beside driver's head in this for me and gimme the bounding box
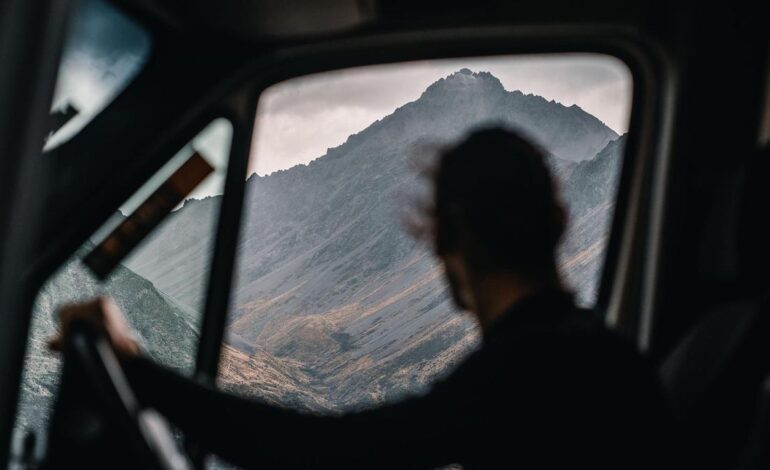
[212,54,632,413]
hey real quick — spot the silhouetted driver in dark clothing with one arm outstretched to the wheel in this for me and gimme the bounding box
[53,128,665,469]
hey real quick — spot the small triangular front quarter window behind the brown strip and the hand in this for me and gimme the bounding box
[15,119,232,456]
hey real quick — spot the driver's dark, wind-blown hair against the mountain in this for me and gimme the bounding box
[416,127,566,280]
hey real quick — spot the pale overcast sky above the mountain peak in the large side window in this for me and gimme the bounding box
[250,54,632,175]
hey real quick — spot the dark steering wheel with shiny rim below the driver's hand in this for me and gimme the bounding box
[44,321,192,470]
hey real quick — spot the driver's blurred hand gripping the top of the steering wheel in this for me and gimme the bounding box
[48,297,140,359]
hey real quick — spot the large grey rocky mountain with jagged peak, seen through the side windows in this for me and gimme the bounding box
[120,69,625,411]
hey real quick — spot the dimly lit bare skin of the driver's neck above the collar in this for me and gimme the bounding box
[473,274,561,332]
